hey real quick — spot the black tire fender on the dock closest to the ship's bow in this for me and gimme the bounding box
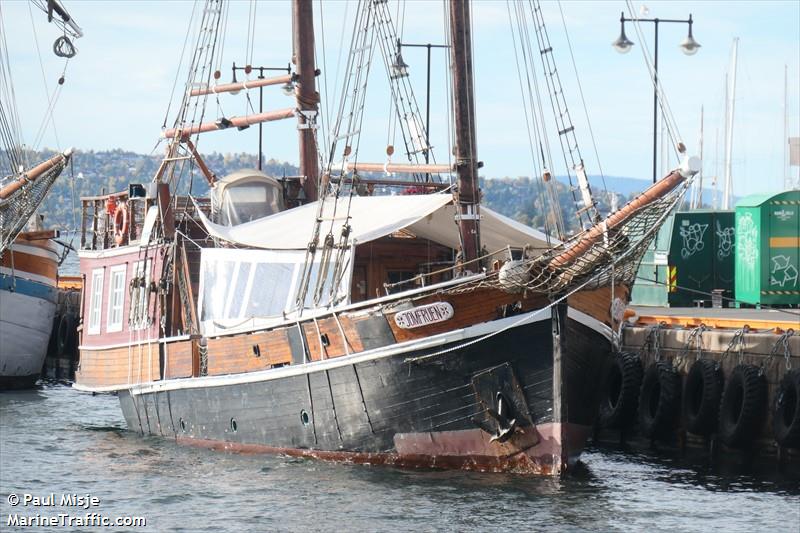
[598,352,644,429]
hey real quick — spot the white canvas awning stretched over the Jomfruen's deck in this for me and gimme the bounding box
[198,194,557,252]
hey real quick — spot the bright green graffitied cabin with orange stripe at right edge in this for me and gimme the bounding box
[736,190,800,306]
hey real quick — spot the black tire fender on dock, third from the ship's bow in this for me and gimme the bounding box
[683,359,725,436]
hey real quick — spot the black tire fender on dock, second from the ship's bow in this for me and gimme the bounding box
[639,361,681,438]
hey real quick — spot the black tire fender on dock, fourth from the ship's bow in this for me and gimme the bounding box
[719,364,767,448]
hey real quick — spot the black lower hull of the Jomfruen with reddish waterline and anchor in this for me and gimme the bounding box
[119,312,610,474]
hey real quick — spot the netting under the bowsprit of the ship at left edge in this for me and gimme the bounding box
[0,158,68,255]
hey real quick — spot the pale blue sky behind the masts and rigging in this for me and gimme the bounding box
[0,0,800,196]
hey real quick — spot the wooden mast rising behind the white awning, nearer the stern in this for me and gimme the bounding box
[292,0,319,202]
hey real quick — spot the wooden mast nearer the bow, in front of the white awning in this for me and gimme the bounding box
[449,0,480,264]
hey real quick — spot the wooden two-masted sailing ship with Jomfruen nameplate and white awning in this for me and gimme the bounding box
[75,0,694,474]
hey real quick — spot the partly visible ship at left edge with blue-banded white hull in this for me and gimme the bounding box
[0,1,82,389]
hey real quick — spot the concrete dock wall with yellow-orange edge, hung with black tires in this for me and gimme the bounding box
[598,306,800,461]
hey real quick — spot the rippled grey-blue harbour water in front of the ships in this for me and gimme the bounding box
[0,385,800,532]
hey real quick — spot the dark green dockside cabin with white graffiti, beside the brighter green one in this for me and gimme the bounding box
[667,209,736,307]
